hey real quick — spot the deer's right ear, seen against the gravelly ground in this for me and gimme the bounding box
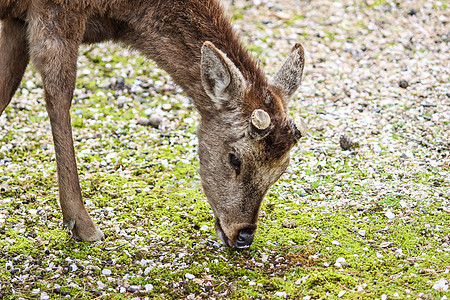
[269,43,305,100]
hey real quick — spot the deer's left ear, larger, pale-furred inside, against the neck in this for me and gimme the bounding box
[201,42,246,109]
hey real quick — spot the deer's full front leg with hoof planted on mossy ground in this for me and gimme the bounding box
[29,14,103,242]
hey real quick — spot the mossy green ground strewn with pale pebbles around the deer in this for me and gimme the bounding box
[0,0,450,299]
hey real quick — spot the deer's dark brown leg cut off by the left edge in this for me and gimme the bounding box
[0,19,30,115]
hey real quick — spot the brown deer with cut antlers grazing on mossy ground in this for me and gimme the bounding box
[0,0,306,248]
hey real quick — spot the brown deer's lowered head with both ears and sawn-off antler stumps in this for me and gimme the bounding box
[198,42,306,248]
